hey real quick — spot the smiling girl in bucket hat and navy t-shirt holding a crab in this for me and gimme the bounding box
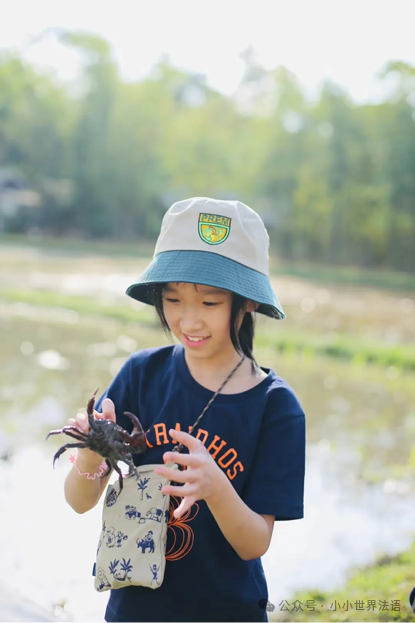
[65,198,305,623]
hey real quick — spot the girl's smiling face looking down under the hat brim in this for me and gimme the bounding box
[163,283,251,360]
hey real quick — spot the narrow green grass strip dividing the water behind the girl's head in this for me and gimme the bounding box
[0,290,415,370]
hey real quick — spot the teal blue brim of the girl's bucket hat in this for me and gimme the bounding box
[126,251,285,320]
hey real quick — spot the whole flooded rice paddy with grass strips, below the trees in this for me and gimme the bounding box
[0,237,415,623]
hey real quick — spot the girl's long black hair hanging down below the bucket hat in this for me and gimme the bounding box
[154,283,259,373]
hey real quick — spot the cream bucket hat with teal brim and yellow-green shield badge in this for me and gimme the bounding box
[126,197,285,320]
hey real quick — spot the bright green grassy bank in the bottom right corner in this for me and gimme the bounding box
[269,542,415,623]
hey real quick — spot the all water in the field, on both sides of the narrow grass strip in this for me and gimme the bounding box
[0,249,415,623]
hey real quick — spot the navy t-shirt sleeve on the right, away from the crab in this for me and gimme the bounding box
[241,386,306,521]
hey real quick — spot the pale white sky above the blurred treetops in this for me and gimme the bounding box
[0,0,415,102]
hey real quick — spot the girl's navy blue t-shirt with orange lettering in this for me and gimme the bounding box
[96,344,306,623]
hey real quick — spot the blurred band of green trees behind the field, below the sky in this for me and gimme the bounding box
[0,31,415,271]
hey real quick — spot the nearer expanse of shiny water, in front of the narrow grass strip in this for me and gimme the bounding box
[0,307,415,623]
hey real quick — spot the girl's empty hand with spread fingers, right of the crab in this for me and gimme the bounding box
[154,429,227,519]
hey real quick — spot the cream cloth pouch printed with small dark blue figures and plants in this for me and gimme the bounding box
[94,463,178,592]
